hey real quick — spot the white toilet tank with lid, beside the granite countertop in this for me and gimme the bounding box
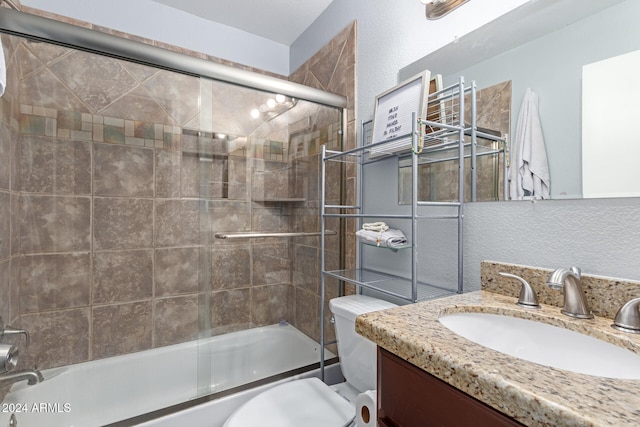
[329,295,397,392]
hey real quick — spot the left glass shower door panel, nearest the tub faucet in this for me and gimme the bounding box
[0,31,215,425]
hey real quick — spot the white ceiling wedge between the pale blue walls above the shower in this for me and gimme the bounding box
[153,0,333,46]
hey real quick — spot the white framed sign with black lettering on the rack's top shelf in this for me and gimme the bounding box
[370,70,431,157]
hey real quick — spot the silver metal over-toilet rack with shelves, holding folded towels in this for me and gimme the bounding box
[320,77,504,382]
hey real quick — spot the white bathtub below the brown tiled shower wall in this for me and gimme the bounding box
[0,325,333,427]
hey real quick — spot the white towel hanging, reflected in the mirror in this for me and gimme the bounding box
[509,89,550,200]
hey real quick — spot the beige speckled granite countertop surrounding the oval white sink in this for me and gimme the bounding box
[356,290,640,426]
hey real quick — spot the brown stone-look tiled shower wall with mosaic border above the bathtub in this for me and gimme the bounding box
[0,10,356,368]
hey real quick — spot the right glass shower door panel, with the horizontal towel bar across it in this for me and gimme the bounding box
[199,81,342,393]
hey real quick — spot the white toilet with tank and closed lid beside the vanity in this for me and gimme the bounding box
[224,295,396,427]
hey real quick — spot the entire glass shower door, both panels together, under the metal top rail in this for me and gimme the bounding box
[0,20,342,425]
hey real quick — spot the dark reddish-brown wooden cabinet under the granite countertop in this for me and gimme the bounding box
[377,347,523,427]
